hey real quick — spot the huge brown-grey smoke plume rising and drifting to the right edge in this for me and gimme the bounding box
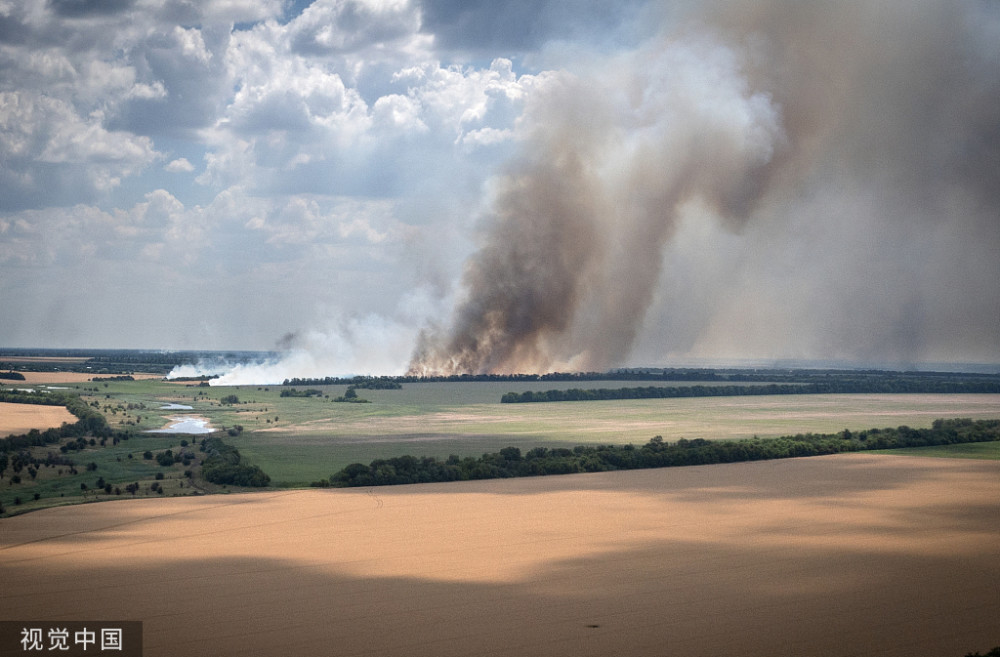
[410,0,1000,373]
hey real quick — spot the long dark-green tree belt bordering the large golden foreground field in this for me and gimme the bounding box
[328,419,1000,486]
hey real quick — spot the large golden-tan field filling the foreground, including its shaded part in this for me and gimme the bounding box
[0,455,1000,657]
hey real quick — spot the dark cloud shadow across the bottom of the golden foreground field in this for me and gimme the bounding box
[0,540,1000,657]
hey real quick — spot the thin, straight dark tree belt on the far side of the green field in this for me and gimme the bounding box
[500,377,1000,404]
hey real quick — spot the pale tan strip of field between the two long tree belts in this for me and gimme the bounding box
[257,394,1000,442]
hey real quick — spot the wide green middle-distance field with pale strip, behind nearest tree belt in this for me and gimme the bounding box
[35,380,1000,486]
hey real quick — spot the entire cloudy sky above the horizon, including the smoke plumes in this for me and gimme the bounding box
[0,0,1000,380]
